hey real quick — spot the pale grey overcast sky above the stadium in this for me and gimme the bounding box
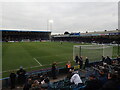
[2,2,118,33]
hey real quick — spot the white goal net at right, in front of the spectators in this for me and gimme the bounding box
[73,45,113,61]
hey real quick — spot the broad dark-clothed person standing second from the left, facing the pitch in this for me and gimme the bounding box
[17,67,26,86]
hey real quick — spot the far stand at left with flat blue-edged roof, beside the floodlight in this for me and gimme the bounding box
[1,29,51,42]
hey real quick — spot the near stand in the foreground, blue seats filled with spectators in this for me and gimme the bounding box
[1,57,120,90]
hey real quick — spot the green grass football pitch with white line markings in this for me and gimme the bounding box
[2,42,117,77]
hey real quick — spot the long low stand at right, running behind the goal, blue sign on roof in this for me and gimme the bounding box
[52,30,120,43]
